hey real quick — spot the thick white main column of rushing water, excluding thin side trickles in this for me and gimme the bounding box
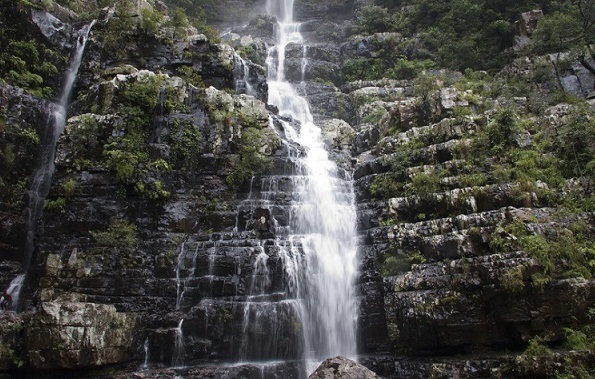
[266,0,357,372]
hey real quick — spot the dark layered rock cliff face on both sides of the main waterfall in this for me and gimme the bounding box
[0,1,595,378]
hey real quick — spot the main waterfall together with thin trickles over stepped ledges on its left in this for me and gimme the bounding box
[163,0,357,379]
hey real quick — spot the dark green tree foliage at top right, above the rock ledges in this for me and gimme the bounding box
[352,0,595,72]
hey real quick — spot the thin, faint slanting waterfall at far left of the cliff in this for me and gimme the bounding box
[21,21,95,271]
